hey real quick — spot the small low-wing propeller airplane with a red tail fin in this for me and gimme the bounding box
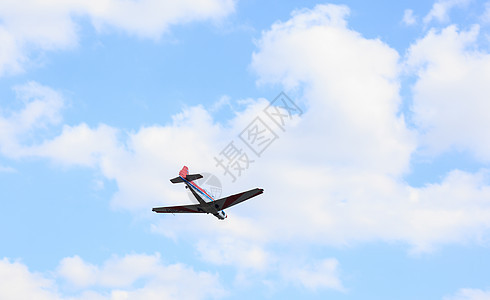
[152,166,264,220]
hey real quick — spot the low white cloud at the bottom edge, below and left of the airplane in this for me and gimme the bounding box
[57,254,226,299]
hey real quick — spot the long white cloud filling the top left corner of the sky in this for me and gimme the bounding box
[0,0,235,76]
